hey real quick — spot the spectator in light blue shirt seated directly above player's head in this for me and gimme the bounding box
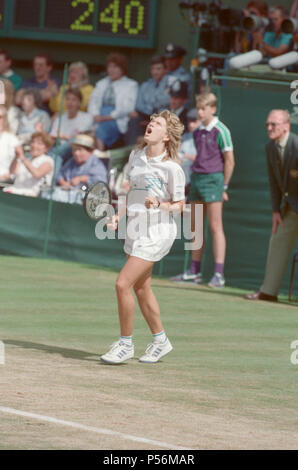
[126,56,170,145]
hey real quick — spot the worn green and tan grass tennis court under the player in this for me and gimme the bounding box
[0,256,298,450]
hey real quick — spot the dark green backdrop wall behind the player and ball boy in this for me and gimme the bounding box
[0,76,298,292]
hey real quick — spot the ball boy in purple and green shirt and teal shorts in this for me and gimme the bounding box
[172,93,234,288]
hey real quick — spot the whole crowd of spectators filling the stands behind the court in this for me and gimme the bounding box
[0,0,298,201]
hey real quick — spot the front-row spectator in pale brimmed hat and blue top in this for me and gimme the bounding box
[44,134,108,203]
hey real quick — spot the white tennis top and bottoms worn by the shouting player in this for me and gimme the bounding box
[124,147,185,262]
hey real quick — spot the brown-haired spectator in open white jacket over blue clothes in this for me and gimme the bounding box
[88,53,138,150]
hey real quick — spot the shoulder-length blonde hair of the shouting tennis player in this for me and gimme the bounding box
[137,109,184,162]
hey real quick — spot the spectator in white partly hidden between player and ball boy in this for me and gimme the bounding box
[179,108,201,187]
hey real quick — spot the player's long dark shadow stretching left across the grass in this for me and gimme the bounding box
[4,340,99,362]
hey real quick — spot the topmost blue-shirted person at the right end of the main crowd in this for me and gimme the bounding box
[164,43,191,99]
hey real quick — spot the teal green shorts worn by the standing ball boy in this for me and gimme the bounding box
[188,172,224,202]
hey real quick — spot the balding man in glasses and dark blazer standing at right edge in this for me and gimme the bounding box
[244,110,298,302]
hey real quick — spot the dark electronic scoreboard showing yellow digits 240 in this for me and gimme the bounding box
[0,0,157,48]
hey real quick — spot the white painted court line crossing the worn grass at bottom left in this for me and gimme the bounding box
[0,406,189,450]
